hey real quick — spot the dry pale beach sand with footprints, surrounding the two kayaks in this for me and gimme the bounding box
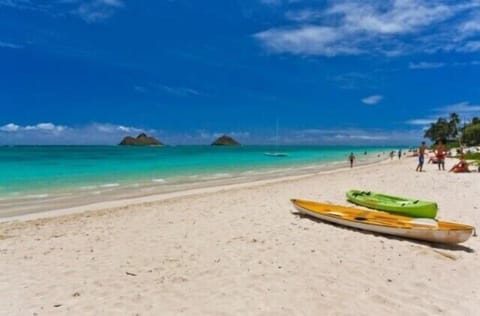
[0,158,480,315]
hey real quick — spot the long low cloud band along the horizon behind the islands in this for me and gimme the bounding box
[0,123,421,145]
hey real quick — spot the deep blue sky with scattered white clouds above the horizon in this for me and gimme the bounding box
[0,0,480,145]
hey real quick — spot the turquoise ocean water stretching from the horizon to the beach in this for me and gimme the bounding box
[0,146,394,216]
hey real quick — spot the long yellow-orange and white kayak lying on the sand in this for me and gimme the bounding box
[291,199,475,244]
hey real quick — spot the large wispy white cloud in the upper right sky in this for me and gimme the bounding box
[254,0,480,56]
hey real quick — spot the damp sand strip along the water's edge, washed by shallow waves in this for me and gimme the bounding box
[0,152,390,223]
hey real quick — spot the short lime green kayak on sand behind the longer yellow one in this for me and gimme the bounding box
[347,190,438,218]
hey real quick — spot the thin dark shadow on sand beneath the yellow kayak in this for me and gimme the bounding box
[291,212,476,253]
